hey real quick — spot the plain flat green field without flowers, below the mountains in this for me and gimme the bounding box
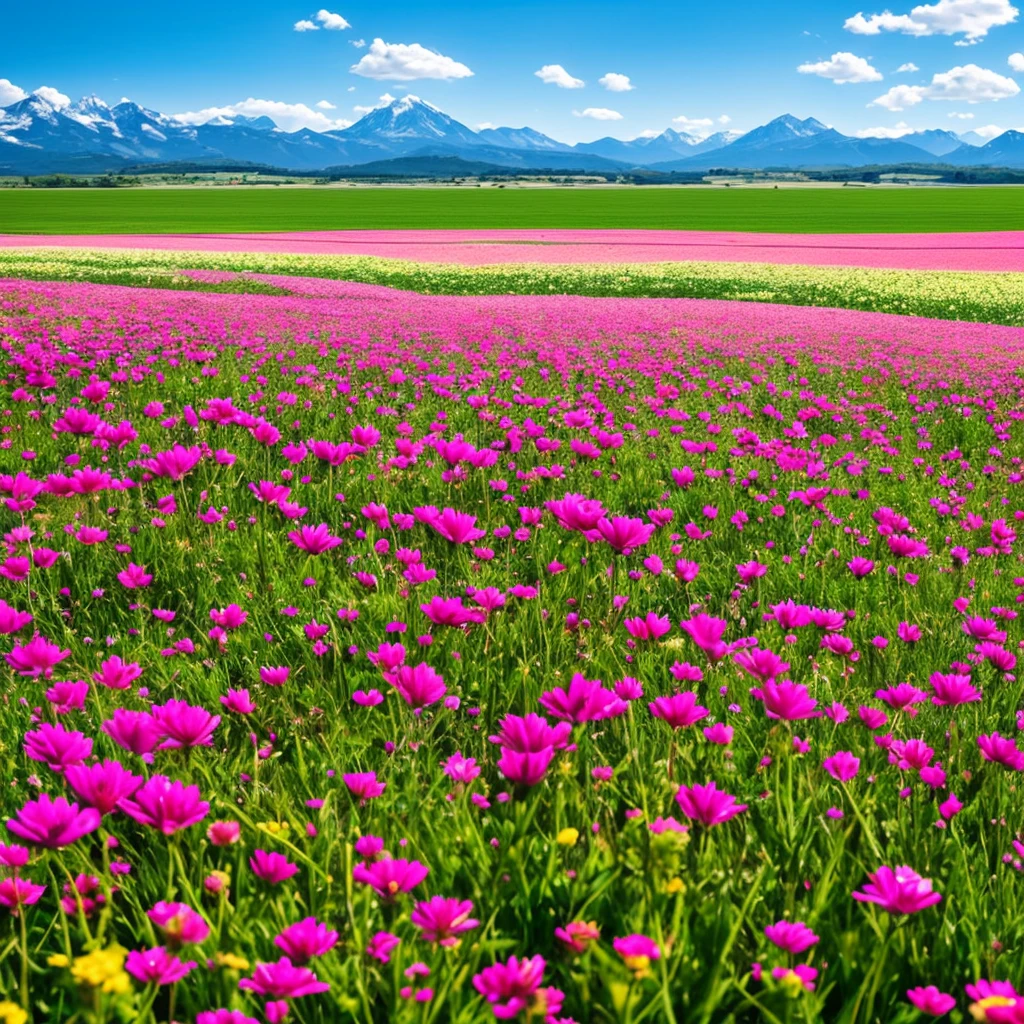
[0,186,1024,234]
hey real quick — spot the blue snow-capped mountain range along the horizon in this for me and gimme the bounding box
[0,93,1024,175]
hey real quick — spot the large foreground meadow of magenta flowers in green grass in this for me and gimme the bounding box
[0,273,1024,1024]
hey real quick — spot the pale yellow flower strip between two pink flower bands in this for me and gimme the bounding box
[0,245,1024,327]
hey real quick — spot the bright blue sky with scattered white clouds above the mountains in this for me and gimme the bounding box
[6,0,1024,142]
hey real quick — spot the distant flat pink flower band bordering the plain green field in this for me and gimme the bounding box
[0,230,1024,271]
